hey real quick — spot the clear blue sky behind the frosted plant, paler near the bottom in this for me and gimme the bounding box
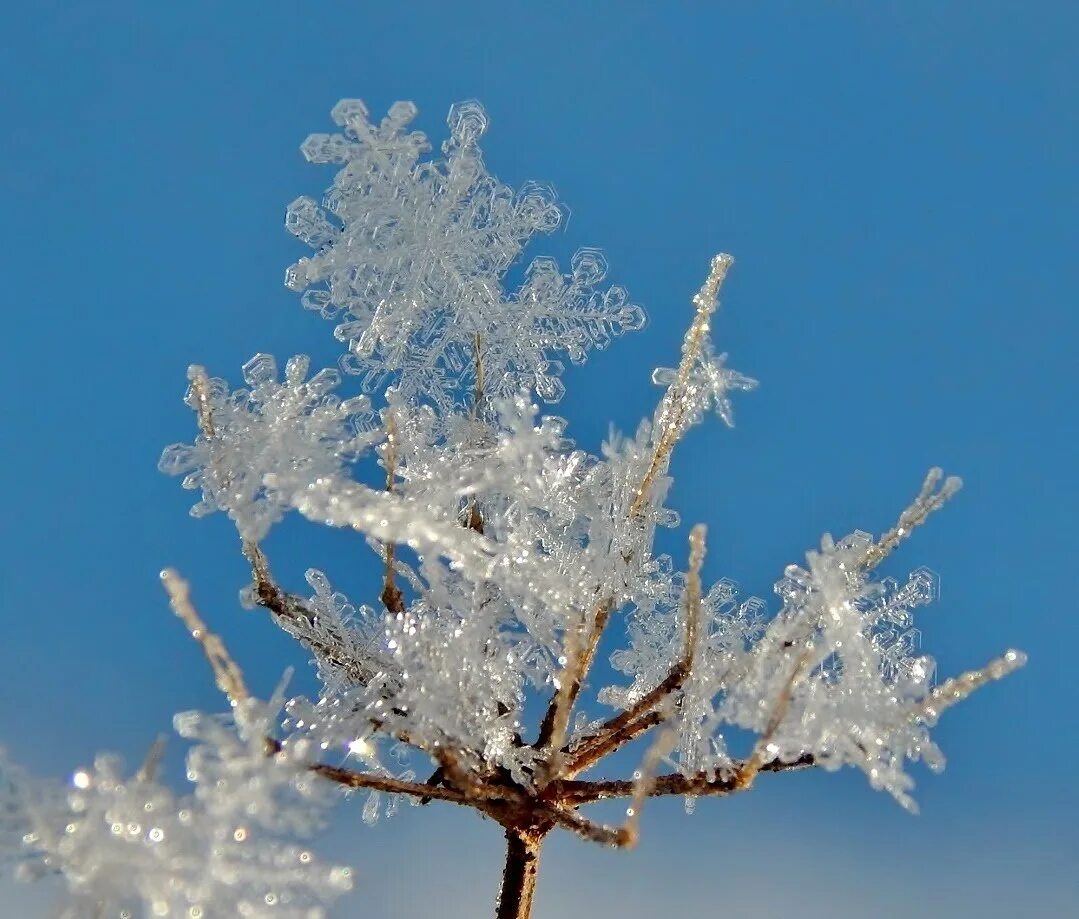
[0,0,1079,919]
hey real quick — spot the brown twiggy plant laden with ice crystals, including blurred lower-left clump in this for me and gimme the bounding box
[2,99,1024,919]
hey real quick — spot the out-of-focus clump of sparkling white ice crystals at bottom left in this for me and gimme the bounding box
[0,699,352,919]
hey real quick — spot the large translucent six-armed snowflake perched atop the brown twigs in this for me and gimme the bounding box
[285,99,644,409]
